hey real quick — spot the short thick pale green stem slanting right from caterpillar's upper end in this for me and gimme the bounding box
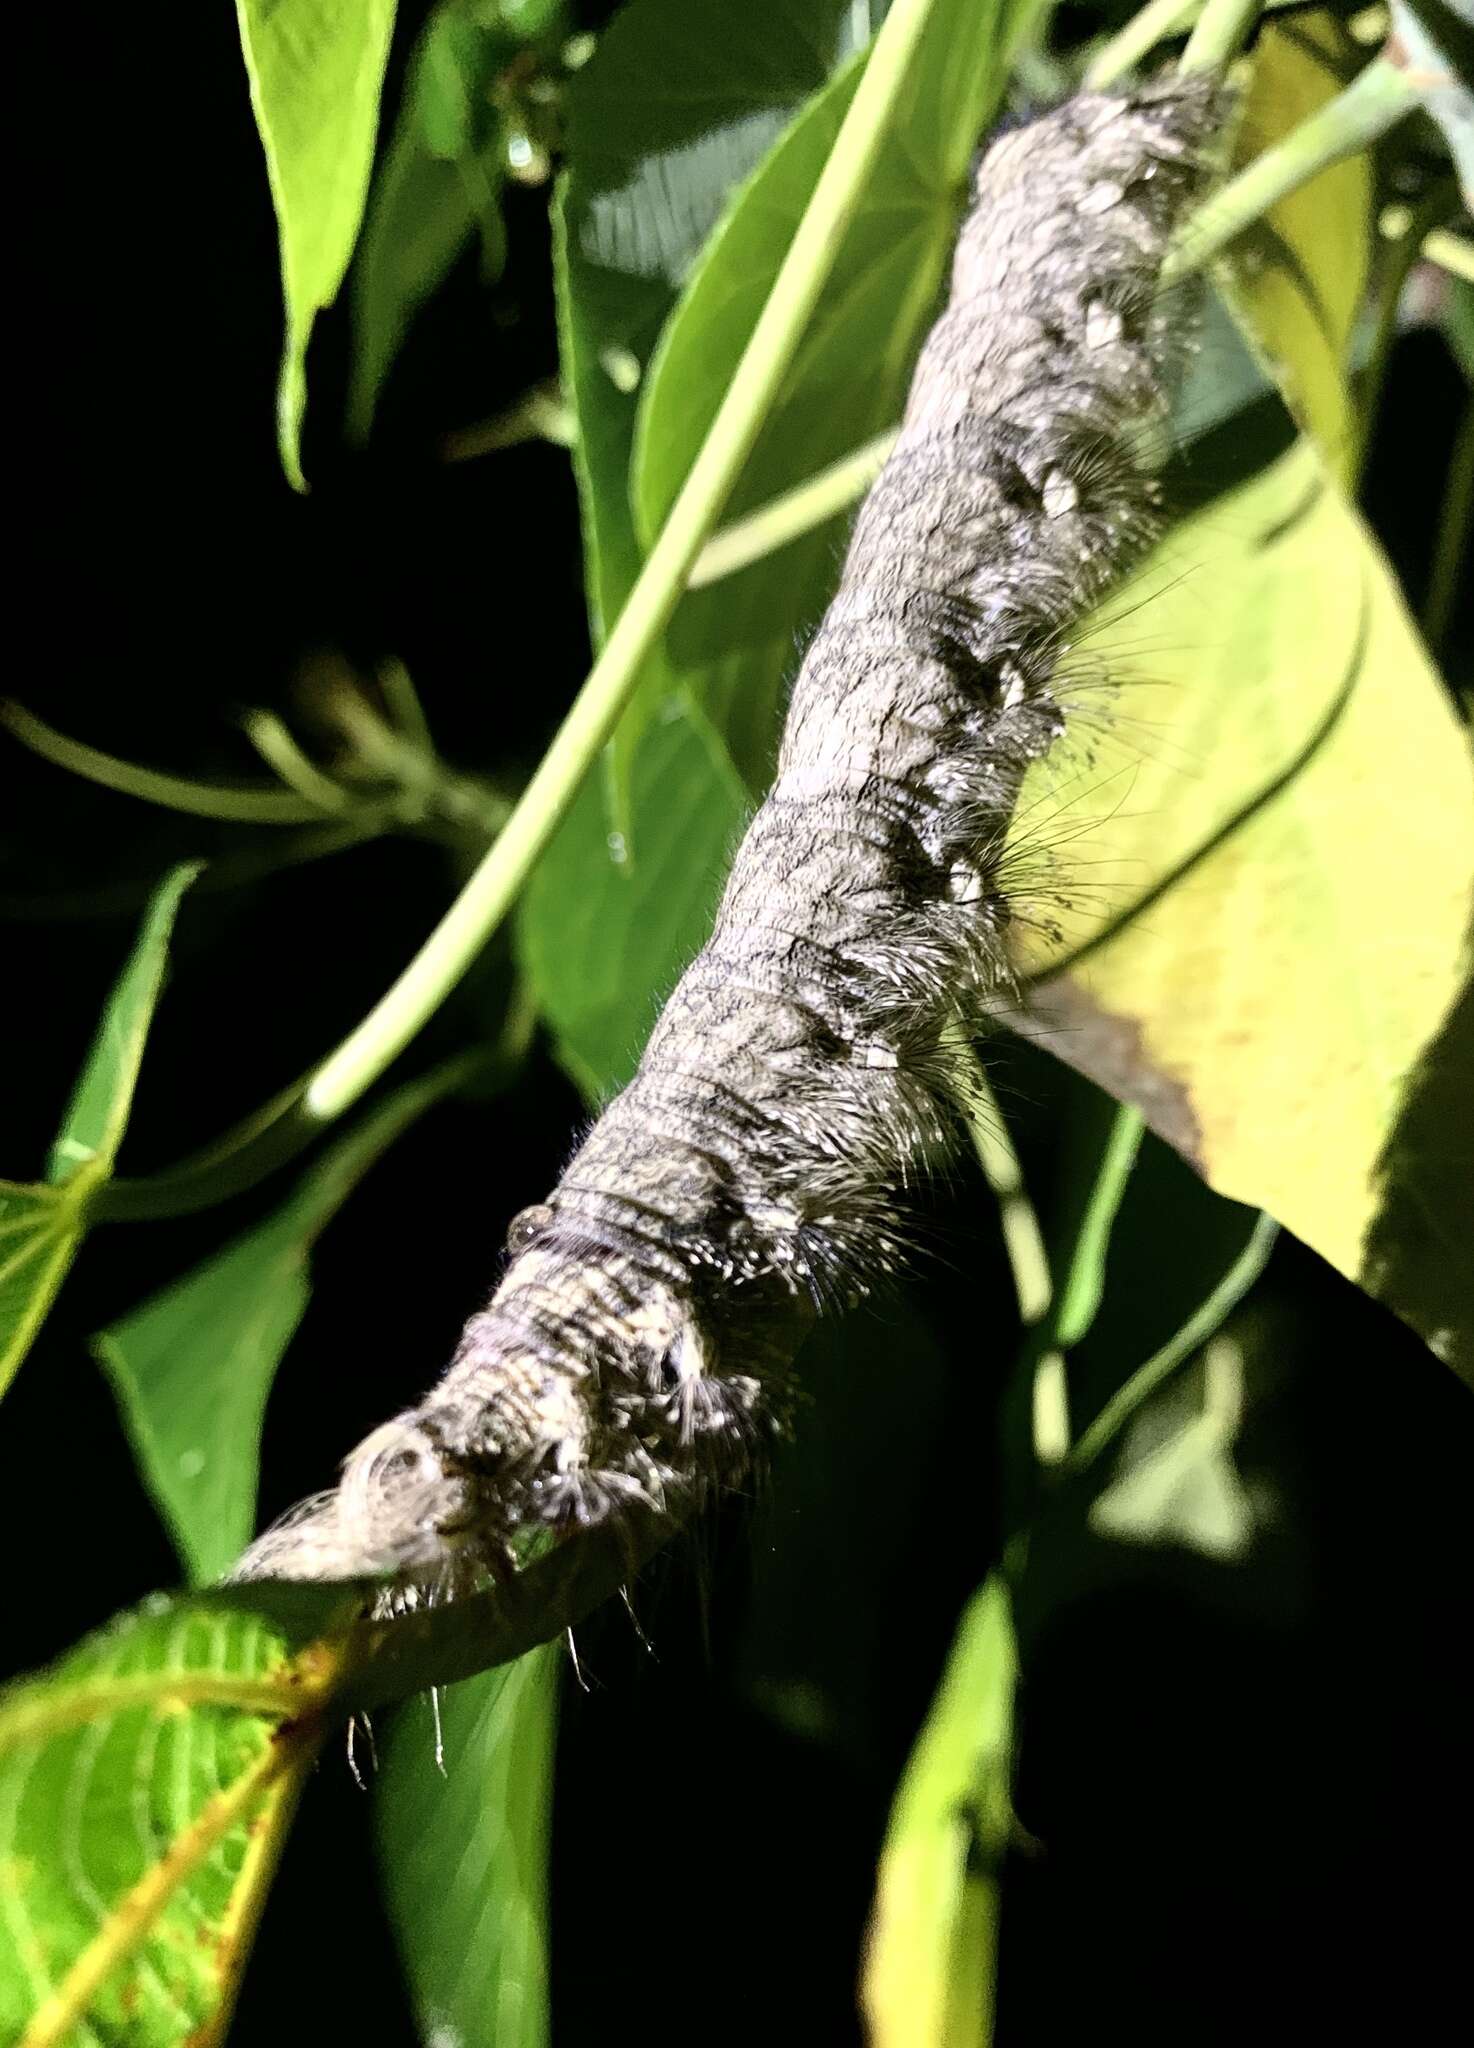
[1163,57,1419,285]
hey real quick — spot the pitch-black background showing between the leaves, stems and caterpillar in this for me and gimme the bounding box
[0,6,1474,2044]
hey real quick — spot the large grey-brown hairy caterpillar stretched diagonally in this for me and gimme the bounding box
[242,78,1222,1587]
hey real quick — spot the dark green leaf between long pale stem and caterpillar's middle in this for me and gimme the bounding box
[518,707,745,1100]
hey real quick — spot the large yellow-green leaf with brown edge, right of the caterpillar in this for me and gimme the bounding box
[1015,442,1474,1374]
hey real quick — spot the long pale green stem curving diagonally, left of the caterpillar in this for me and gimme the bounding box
[305,0,936,1120]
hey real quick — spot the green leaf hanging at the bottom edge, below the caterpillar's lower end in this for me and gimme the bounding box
[375,1645,561,2048]
